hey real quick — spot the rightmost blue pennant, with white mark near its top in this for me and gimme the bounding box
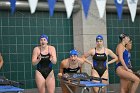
[114,0,124,20]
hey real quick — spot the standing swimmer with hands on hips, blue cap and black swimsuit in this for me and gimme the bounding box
[83,35,118,93]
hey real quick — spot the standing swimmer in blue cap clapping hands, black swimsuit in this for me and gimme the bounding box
[32,34,57,93]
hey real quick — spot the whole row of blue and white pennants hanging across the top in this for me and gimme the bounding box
[9,0,138,22]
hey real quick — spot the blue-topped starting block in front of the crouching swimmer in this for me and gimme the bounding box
[60,73,107,93]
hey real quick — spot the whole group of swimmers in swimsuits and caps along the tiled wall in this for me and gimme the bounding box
[0,33,140,93]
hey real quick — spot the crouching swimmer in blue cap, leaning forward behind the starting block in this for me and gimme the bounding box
[58,49,91,93]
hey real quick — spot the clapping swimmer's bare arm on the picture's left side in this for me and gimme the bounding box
[32,47,41,65]
